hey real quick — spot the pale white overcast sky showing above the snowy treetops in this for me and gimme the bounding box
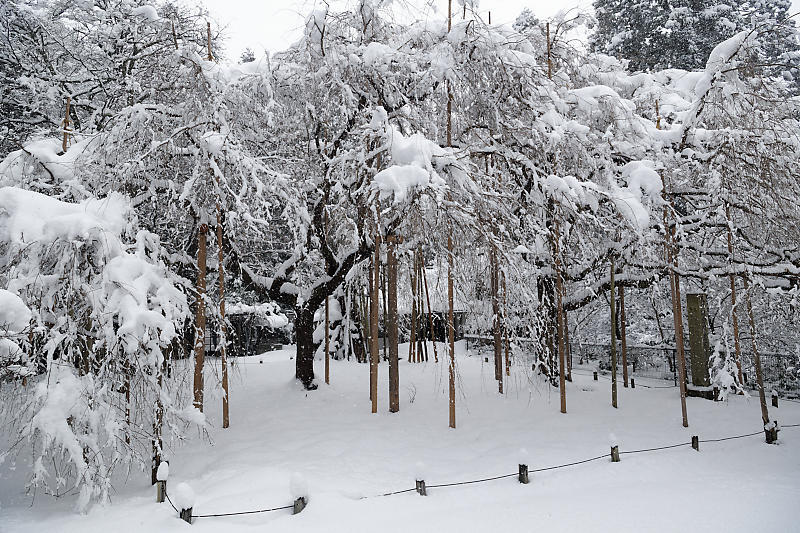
[204,0,800,59]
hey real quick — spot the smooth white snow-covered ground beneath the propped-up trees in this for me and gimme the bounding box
[0,343,800,533]
